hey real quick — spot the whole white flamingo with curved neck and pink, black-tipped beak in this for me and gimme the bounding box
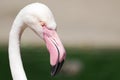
[8,3,66,80]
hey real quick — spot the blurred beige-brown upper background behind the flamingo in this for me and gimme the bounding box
[0,0,120,47]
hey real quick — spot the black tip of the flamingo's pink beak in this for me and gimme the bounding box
[51,60,64,76]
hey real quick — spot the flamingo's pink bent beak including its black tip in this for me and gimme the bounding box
[43,27,66,76]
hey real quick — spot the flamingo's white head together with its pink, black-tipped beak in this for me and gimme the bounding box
[25,4,66,76]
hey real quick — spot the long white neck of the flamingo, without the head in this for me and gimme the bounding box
[9,19,27,80]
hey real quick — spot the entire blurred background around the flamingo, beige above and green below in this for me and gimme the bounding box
[0,0,120,80]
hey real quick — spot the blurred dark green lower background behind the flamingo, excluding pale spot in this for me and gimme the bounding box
[0,45,120,80]
